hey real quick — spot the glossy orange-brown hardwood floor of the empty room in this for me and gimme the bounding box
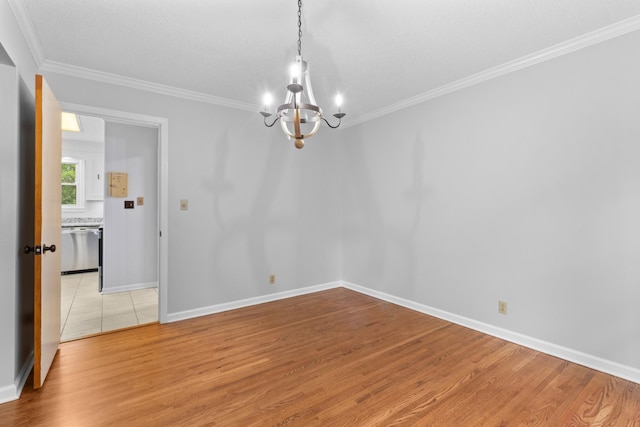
[0,288,640,426]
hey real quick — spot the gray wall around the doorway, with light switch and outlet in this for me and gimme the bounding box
[40,74,342,315]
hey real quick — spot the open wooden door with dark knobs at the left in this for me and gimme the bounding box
[32,75,62,388]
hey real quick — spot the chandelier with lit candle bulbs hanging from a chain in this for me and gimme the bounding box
[260,0,345,148]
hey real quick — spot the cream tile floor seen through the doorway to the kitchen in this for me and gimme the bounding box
[60,272,158,341]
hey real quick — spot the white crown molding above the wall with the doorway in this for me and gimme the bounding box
[40,60,260,112]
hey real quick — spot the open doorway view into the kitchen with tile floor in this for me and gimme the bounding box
[61,113,158,341]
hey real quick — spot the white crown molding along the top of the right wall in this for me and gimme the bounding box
[345,15,640,127]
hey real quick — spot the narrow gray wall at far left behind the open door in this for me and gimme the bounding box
[0,45,35,402]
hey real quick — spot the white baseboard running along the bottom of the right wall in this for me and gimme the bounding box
[343,282,640,384]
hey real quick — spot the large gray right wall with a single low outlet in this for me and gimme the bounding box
[343,32,640,369]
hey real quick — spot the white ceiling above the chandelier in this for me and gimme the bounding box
[10,0,640,123]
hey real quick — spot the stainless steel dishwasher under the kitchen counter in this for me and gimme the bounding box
[60,226,100,273]
